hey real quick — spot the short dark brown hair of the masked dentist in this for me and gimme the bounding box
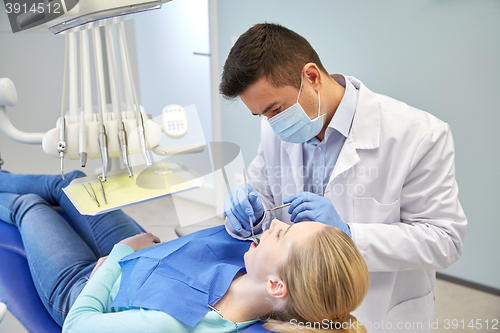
[219,23,327,99]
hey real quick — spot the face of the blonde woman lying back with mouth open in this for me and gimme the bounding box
[245,220,325,280]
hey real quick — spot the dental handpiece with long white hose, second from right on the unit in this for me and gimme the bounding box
[105,25,134,178]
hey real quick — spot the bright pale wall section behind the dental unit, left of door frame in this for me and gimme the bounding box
[135,0,214,196]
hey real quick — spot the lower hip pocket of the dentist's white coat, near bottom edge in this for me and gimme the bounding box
[385,291,435,332]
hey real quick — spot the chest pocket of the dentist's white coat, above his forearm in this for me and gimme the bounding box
[353,197,400,223]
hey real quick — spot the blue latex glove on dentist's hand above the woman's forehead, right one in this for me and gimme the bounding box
[283,192,352,237]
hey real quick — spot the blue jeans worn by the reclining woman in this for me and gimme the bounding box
[0,170,141,326]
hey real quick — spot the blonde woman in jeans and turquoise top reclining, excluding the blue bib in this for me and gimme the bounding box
[0,171,369,333]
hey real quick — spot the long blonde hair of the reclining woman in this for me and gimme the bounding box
[264,222,370,333]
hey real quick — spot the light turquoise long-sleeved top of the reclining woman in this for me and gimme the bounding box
[63,244,193,333]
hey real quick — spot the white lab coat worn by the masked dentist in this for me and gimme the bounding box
[226,77,467,332]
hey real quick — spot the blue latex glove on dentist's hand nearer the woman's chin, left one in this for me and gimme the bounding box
[224,184,264,232]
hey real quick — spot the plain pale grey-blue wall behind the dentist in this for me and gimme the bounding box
[218,0,500,288]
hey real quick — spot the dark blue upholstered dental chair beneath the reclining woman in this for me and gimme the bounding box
[0,207,269,333]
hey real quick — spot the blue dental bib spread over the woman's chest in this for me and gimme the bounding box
[109,226,250,327]
